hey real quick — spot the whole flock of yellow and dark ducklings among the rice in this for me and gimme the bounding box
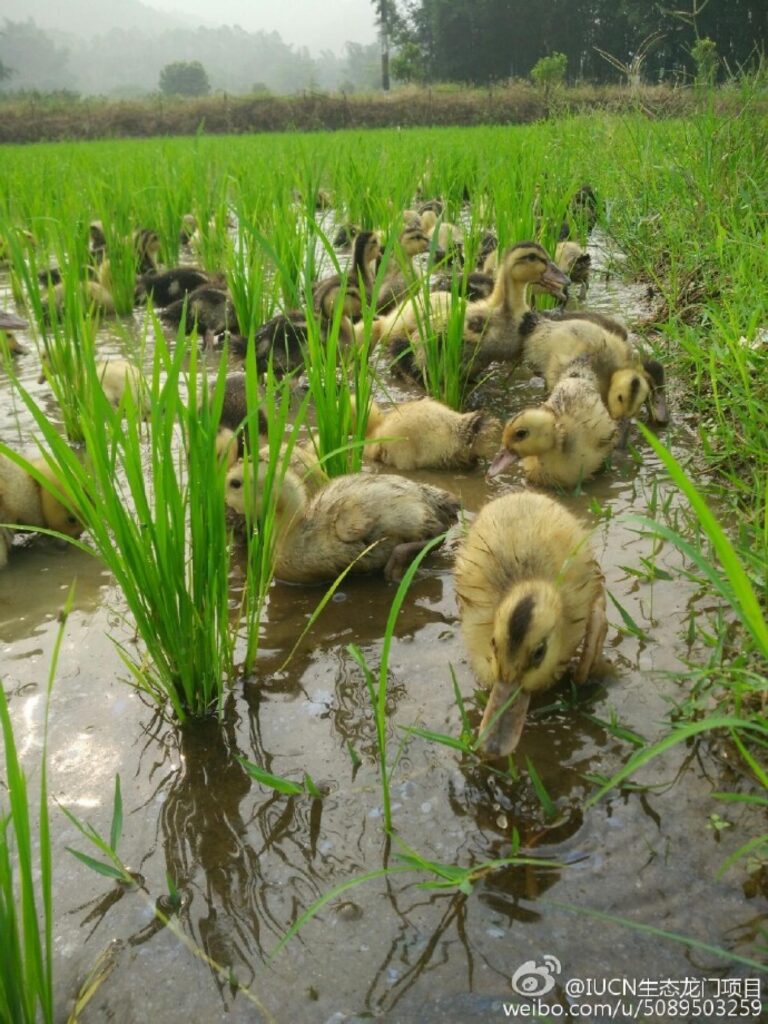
[0,189,667,756]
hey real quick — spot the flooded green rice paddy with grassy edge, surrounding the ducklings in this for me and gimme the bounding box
[0,105,768,1024]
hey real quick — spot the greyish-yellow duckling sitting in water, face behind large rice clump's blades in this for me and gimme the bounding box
[225,463,460,583]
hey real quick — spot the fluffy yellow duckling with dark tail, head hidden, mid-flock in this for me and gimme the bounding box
[365,398,502,470]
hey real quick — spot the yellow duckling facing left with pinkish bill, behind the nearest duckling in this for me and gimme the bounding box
[488,364,620,488]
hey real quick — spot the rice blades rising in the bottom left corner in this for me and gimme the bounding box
[0,587,74,1024]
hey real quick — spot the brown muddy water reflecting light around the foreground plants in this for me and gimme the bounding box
[0,232,766,1024]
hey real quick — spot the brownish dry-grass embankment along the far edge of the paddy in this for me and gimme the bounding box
[0,82,737,142]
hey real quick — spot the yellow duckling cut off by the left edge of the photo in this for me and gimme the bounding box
[0,455,83,568]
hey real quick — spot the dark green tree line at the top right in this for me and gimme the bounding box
[387,0,768,85]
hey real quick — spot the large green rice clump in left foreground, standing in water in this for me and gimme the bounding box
[2,327,246,721]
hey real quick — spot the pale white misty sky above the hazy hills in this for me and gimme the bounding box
[144,0,376,53]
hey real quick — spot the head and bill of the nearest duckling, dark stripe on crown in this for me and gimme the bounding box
[480,580,568,757]
